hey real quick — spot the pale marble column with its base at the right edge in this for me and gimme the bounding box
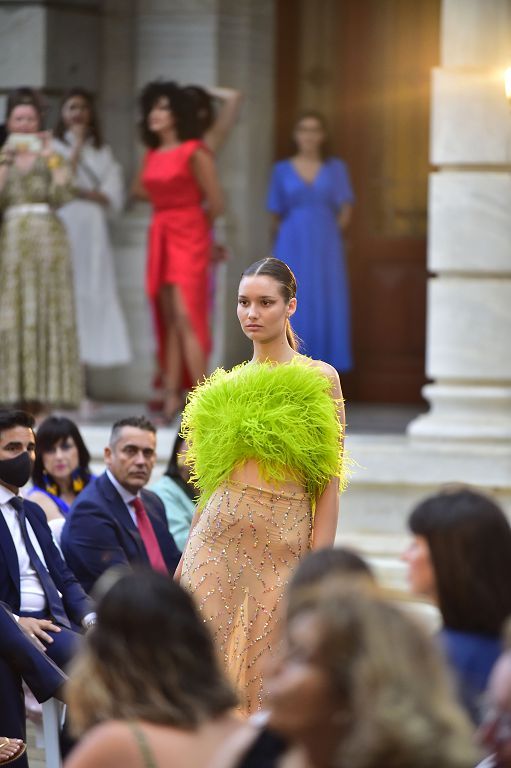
[409,0,511,441]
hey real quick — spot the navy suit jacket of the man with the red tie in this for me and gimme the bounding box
[60,472,181,592]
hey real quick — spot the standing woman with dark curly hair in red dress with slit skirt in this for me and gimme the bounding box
[134,81,223,420]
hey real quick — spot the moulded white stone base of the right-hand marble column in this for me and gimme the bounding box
[407,383,511,441]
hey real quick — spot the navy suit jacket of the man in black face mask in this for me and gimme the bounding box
[0,499,94,626]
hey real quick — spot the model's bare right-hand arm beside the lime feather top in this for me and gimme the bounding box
[312,363,346,549]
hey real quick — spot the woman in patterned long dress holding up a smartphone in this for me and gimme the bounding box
[0,88,82,412]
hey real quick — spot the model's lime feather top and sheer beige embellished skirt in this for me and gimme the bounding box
[181,356,342,712]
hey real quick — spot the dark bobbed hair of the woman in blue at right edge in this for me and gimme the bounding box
[408,486,511,635]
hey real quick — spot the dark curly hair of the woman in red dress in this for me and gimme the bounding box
[138,80,199,149]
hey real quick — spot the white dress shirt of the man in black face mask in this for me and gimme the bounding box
[0,485,47,611]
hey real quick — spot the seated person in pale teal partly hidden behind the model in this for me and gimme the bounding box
[151,425,197,552]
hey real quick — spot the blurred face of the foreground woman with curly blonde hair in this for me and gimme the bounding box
[266,612,338,742]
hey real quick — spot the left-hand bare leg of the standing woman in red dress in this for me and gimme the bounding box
[158,285,183,419]
